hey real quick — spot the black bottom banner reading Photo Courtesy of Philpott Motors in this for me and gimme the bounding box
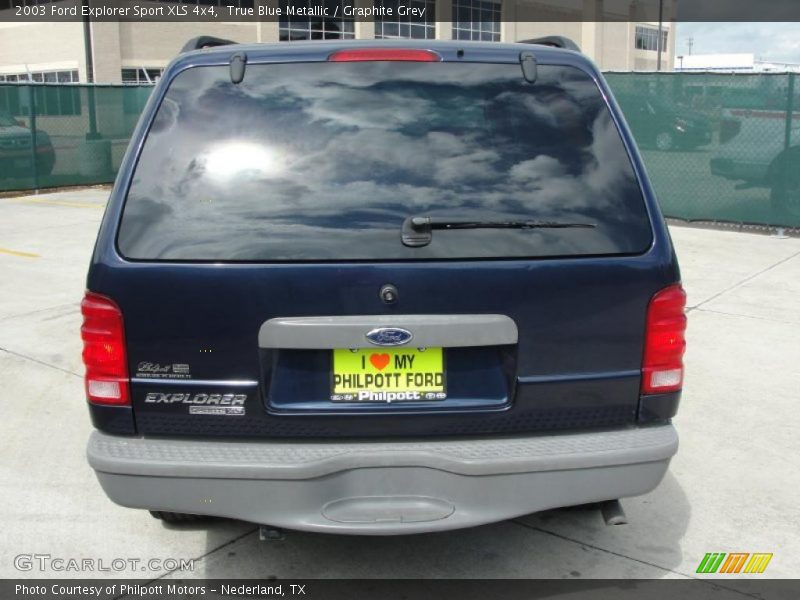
[0,578,800,600]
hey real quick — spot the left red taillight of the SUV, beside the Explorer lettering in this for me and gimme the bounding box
[81,292,130,404]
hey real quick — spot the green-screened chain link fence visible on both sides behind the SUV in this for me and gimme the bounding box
[0,73,800,228]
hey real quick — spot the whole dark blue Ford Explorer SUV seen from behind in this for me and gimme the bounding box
[82,41,686,534]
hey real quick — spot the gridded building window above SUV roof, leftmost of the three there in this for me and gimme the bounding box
[278,0,356,42]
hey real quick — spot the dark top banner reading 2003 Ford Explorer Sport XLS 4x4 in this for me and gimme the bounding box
[0,0,800,23]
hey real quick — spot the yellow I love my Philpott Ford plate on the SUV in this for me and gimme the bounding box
[331,348,447,402]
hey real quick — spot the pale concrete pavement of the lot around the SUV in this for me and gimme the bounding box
[0,190,800,580]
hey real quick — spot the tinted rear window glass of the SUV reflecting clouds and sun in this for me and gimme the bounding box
[118,62,651,261]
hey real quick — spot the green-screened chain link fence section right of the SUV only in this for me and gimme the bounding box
[606,73,800,228]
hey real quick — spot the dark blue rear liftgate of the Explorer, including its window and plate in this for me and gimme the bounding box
[89,47,678,437]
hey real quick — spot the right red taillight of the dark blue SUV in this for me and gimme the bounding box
[642,284,686,394]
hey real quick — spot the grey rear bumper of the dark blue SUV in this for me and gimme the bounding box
[87,425,678,534]
